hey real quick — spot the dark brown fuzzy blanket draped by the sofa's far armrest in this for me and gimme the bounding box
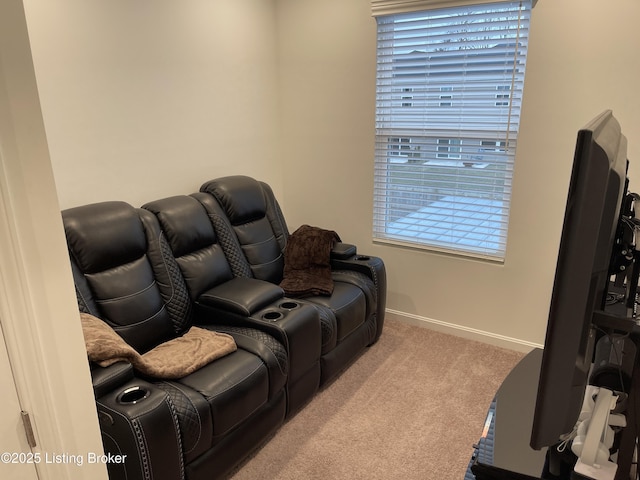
[280,225,340,297]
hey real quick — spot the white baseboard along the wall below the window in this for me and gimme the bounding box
[386,308,543,353]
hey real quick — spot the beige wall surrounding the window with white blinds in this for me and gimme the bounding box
[278,0,640,344]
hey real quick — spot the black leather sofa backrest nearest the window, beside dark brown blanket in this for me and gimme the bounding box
[200,175,289,283]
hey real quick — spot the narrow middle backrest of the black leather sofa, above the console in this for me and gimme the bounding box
[142,195,234,301]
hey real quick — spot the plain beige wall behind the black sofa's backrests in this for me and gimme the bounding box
[24,0,281,208]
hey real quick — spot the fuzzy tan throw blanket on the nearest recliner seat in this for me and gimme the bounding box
[80,313,237,379]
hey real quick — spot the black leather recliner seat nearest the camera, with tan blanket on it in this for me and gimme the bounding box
[63,202,288,479]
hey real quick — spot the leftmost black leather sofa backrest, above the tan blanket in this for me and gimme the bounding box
[62,202,192,353]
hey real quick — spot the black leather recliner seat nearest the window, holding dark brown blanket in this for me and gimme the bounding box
[194,175,386,385]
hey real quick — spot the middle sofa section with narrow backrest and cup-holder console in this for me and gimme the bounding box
[142,195,321,413]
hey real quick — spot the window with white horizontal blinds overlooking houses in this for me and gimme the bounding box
[372,0,531,261]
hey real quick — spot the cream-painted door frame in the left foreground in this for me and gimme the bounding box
[0,0,107,480]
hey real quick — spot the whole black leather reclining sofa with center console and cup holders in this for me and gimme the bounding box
[62,176,386,480]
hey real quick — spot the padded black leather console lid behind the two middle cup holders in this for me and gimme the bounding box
[198,277,284,317]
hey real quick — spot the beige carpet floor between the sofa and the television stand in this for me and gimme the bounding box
[232,320,523,480]
